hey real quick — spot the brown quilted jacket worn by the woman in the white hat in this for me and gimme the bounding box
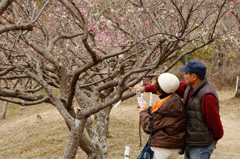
[140,94,186,149]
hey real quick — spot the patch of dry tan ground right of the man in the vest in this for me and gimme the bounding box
[211,91,240,159]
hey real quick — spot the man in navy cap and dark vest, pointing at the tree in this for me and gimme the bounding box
[130,60,223,159]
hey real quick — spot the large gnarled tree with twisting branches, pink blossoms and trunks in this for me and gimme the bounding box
[0,0,238,158]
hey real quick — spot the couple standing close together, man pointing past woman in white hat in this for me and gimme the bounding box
[130,60,223,159]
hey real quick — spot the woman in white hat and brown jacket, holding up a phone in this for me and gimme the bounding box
[139,73,186,159]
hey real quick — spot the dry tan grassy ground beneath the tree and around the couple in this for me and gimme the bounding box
[0,91,240,159]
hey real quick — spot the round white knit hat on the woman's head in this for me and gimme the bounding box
[158,73,179,93]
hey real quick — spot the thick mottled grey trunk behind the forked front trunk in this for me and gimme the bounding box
[76,88,112,159]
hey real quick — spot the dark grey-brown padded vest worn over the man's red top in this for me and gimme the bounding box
[183,78,219,146]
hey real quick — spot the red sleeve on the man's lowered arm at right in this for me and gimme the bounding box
[201,94,223,140]
